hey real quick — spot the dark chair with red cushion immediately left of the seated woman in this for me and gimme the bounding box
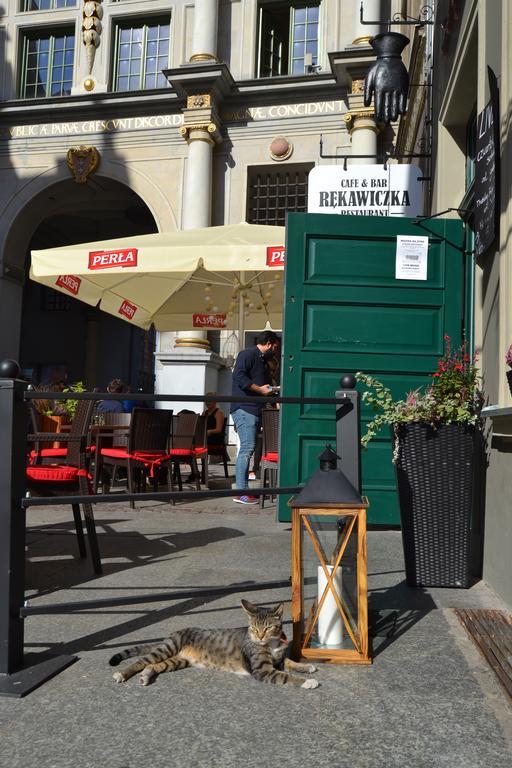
[169,411,208,491]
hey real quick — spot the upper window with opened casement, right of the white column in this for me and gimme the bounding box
[258,2,320,77]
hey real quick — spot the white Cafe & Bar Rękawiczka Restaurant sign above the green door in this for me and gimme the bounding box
[308,164,423,216]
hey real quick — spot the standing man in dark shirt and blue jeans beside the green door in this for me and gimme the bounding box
[231,331,279,504]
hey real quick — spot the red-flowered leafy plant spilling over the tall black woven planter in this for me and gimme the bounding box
[356,336,484,456]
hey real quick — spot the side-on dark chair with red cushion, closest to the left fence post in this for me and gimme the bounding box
[26,400,102,574]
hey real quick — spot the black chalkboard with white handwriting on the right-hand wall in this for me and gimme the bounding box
[474,68,499,258]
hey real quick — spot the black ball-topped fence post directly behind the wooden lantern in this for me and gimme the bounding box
[335,374,361,493]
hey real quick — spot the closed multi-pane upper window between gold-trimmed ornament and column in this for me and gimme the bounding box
[112,19,171,91]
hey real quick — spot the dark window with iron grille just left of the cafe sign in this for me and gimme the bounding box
[247,163,313,226]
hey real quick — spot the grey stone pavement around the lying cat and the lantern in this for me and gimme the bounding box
[0,480,512,768]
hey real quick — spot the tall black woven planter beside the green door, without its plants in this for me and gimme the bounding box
[396,423,483,588]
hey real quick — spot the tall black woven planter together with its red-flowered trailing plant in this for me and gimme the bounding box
[356,336,484,587]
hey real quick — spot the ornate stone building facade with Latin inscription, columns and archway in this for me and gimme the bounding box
[0,0,388,391]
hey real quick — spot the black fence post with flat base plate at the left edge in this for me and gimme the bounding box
[0,360,74,697]
